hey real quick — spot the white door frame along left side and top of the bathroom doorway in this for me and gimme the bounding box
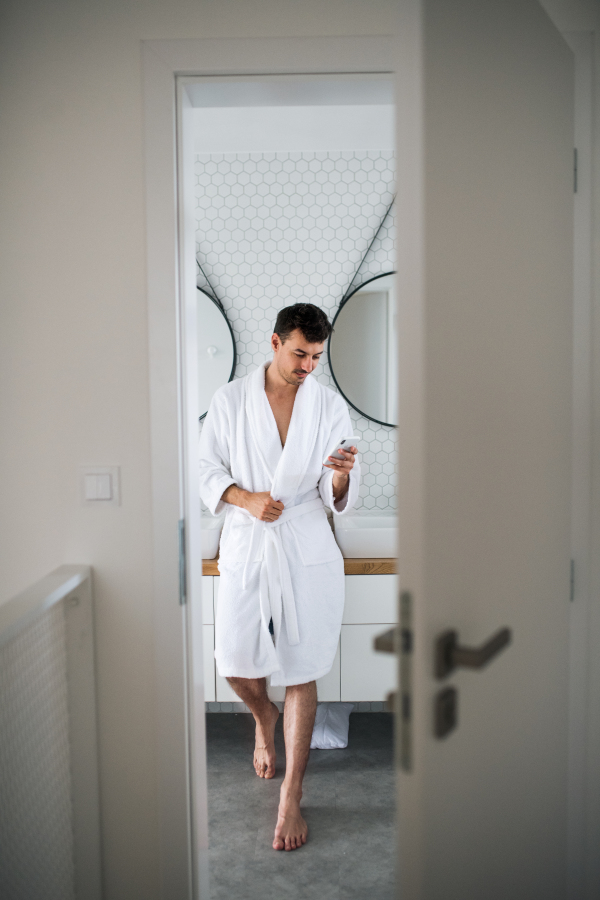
[142,31,398,900]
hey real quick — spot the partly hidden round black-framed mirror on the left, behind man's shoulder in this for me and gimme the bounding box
[197,288,236,419]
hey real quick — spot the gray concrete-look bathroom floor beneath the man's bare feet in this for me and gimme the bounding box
[206,713,396,900]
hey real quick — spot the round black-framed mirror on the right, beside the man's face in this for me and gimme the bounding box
[328,272,398,426]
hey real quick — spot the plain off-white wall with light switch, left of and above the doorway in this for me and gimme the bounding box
[0,0,396,900]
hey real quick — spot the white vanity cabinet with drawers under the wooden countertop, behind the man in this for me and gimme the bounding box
[202,575,397,703]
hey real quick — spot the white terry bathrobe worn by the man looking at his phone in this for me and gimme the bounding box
[200,363,360,685]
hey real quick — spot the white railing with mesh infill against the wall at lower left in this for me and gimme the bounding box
[0,566,102,900]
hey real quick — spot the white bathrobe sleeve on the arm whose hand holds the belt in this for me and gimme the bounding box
[199,391,235,516]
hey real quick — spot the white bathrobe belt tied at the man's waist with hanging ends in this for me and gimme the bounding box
[242,497,323,646]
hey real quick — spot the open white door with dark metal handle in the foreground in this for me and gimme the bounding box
[398,0,573,900]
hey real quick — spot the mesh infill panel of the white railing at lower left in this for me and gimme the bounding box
[0,603,74,900]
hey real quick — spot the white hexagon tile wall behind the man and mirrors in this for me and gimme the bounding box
[196,150,396,511]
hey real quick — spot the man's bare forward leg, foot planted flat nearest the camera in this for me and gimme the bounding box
[273,681,317,850]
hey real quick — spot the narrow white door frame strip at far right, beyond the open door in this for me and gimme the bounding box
[563,31,600,900]
